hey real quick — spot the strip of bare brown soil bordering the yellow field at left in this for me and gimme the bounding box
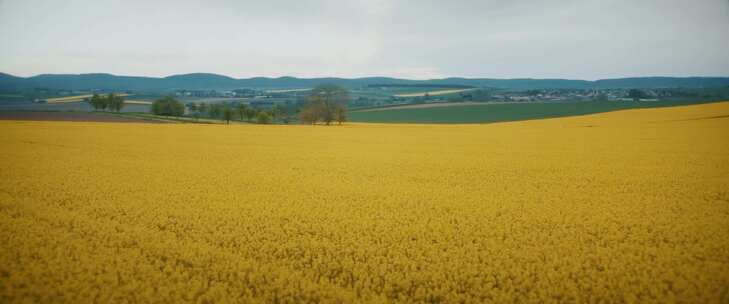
[0,111,160,123]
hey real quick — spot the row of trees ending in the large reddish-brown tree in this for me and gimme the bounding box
[151,85,350,125]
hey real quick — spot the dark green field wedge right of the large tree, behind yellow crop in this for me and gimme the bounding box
[349,100,724,124]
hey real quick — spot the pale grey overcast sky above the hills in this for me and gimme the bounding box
[0,0,729,79]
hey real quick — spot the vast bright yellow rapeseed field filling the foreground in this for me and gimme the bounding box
[0,103,729,303]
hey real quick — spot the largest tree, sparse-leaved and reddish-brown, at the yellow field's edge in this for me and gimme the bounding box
[300,84,349,125]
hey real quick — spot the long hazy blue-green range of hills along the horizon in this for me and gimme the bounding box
[0,73,729,91]
